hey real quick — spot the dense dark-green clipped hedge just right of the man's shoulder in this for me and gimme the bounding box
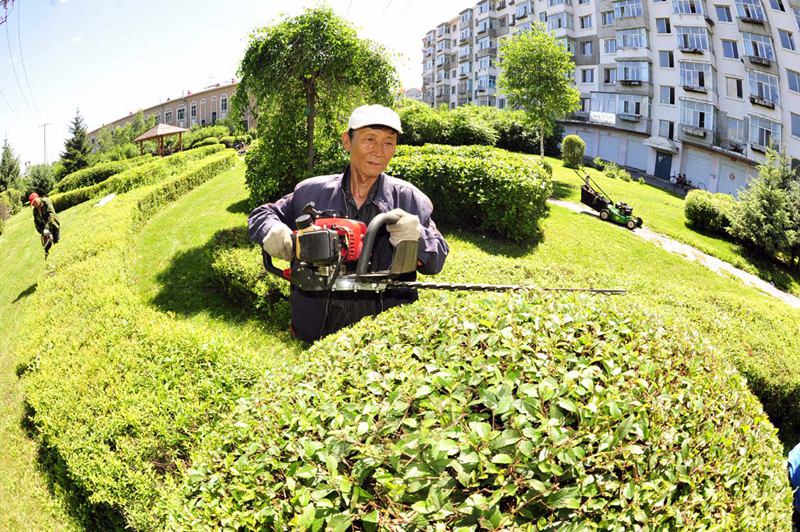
[387,145,552,241]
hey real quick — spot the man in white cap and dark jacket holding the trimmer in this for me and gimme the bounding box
[248,105,449,342]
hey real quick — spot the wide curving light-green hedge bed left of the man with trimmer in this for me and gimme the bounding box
[16,150,241,530]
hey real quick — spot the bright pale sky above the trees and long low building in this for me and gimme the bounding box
[0,0,474,168]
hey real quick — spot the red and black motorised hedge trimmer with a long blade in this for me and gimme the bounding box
[263,203,626,294]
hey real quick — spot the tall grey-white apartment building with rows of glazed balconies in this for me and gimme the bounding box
[423,0,800,194]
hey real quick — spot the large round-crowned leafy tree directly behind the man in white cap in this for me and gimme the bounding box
[233,8,397,203]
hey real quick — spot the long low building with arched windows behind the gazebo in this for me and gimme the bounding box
[88,80,252,146]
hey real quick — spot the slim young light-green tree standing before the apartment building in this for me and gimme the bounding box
[498,23,580,155]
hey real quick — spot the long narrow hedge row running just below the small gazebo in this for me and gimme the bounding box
[50,144,225,212]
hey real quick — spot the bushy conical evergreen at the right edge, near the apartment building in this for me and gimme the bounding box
[730,149,797,258]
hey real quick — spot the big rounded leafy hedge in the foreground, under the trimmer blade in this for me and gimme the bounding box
[170,296,791,530]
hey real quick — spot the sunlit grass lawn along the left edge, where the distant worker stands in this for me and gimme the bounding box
[0,209,80,530]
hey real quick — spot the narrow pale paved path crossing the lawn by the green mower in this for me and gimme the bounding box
[547,199,800,308]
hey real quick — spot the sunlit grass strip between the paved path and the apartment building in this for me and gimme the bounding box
[547,157,800,296]
